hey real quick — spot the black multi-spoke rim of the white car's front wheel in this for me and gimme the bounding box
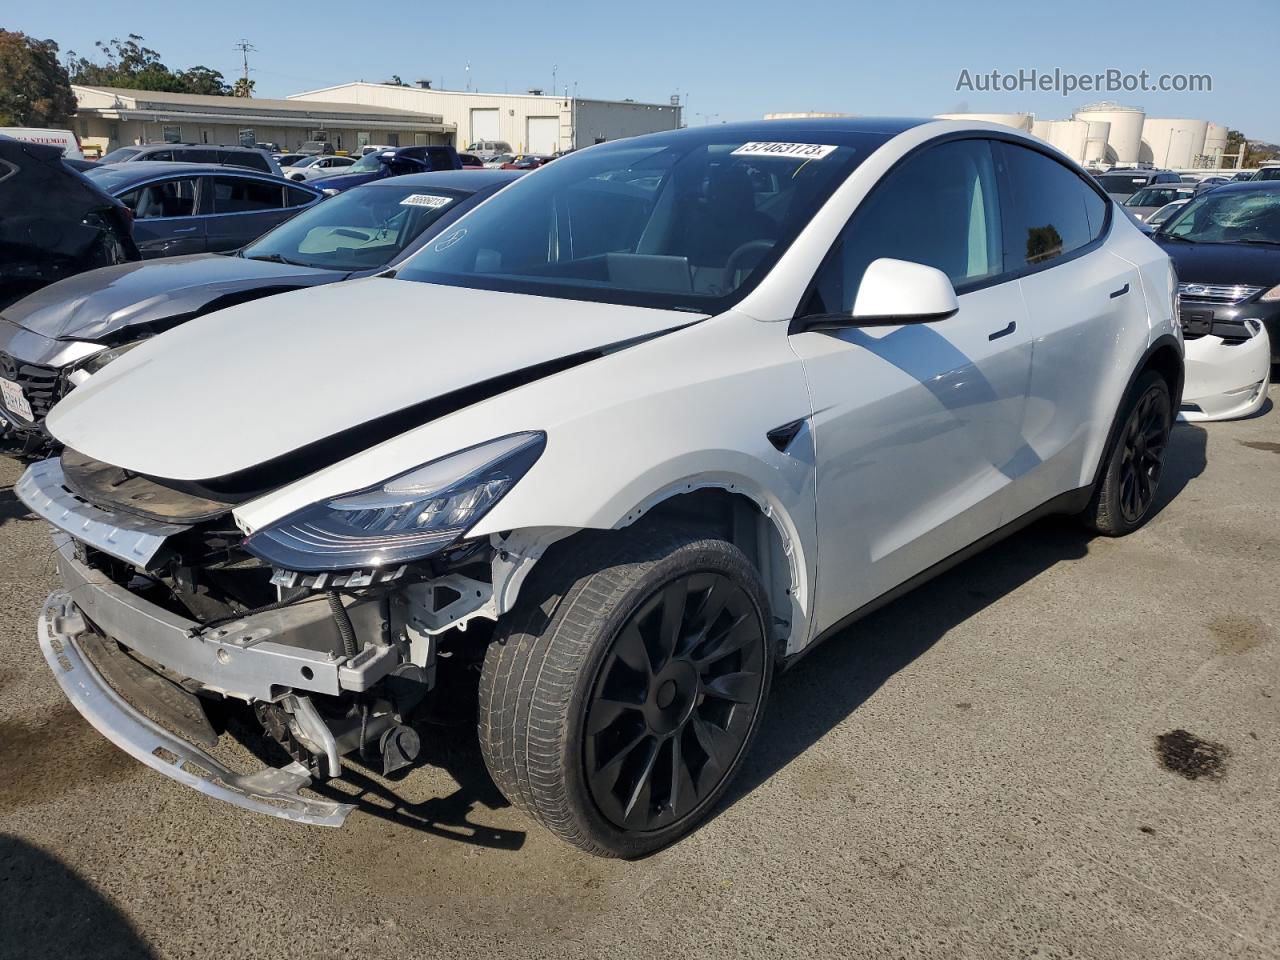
[584,572,767,832]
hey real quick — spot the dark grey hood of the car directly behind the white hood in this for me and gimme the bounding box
[4,253,347,340]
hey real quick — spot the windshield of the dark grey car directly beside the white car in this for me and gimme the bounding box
[241,184,471,270]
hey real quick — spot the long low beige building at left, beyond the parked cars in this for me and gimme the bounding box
[72,84,456,154]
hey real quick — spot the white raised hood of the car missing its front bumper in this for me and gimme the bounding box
[47,278,699,484]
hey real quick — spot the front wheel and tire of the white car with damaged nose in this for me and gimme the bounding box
[479,529,773,858]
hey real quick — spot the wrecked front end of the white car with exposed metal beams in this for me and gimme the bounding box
[15,444,550,826]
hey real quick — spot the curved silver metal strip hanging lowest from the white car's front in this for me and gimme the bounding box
[38,591,353,827]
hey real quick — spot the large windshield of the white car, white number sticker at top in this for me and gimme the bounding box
[398,128,884,312]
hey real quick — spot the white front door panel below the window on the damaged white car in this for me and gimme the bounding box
[791,282,1036,631]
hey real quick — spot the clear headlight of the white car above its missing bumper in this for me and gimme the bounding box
[244,433,547,572]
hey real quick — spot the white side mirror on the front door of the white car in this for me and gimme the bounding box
[791,257,960,333]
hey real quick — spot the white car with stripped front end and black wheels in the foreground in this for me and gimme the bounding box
[17,119,1183,856]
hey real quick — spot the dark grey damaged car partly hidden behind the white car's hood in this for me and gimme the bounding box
[0,170,520,453]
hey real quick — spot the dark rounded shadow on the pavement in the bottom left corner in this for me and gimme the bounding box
[0,833,155,960]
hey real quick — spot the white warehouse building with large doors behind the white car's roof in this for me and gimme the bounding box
[281,81,680,154]
